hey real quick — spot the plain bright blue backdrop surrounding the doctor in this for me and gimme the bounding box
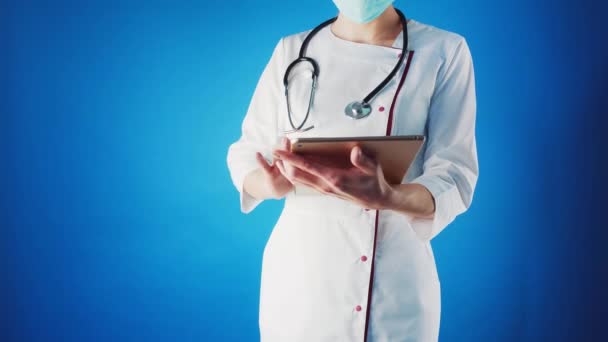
[0,0,608,341]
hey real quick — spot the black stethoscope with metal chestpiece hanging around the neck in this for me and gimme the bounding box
[283,8,408,134]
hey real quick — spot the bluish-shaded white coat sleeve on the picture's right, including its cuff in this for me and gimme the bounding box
[411,36,479,241]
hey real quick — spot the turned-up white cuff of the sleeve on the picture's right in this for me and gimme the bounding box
[410,175,458,241]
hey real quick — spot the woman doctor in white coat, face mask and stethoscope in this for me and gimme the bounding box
[227,0,478,342]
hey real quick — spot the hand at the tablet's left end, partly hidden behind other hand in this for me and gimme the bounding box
[248,138,293,199]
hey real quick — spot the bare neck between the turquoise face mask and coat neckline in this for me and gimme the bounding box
[330,5,403,47]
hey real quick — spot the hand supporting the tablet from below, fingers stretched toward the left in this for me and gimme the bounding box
[273,146,393,209]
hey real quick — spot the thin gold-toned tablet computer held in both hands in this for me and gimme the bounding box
[291,135,425,184]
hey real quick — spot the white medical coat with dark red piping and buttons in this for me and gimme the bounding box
[227,19,478,342]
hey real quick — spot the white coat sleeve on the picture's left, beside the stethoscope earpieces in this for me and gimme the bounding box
[226,39,284,213]
